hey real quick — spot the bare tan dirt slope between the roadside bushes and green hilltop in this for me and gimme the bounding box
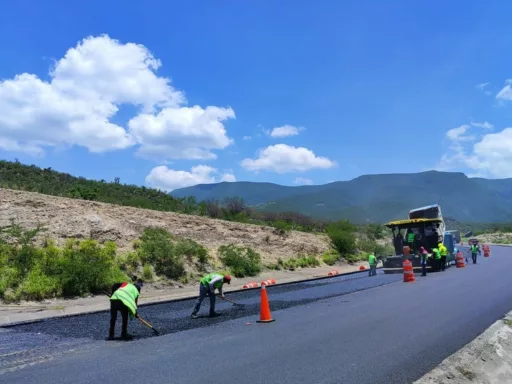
[0,189,329,262]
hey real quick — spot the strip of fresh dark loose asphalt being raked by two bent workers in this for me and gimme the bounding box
[5,272,402,340]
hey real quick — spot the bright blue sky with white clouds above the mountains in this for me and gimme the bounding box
[0,0,512,190]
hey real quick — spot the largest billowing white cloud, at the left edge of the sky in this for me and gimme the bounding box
[0,35,235,161]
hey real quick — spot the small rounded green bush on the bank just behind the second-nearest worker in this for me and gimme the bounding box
[218,244,261,277]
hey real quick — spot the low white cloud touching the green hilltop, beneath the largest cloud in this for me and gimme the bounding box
[142,165,236,192]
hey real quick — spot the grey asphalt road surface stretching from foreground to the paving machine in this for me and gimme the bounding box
[0,247,512,384]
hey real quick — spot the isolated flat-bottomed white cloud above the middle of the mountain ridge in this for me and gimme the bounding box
[240,144,336,173]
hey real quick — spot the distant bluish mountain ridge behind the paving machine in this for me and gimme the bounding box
[171,171,512,223]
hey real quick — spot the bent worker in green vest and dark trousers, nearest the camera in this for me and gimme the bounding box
[108,280,143,340]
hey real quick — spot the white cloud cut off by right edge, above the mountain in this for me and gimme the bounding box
[436,123,512,178]
